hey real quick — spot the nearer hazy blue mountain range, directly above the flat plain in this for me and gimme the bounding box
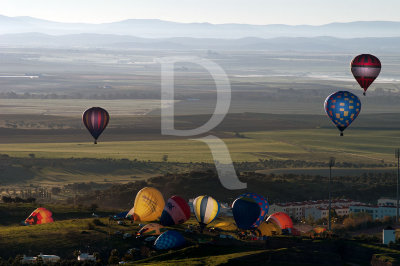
[0,33,400,52]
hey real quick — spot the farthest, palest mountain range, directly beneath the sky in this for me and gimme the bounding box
[0,15,400,39]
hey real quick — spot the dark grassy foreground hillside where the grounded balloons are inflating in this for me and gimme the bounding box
[0,204,400,265]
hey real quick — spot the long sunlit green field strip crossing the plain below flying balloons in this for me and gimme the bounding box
[0,128,400,164]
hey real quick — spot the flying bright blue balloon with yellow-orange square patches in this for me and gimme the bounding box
[325,91,361,136]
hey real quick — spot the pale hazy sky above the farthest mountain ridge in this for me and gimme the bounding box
[0,0,400,25]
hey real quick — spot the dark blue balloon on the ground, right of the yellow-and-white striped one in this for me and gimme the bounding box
[232,193,269,230]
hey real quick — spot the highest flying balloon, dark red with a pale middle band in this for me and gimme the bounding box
[350,54,381,96]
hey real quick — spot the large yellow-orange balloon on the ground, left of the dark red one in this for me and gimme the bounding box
[126,187,165,222]
